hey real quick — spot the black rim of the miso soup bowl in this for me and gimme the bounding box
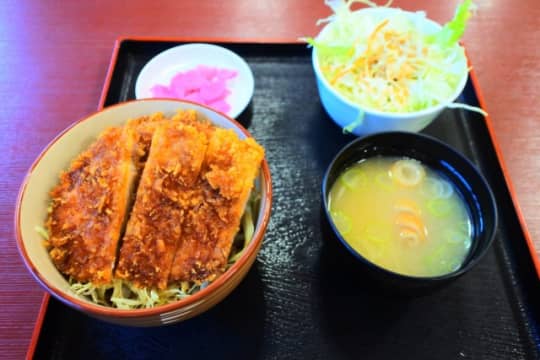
[321,131,498,283]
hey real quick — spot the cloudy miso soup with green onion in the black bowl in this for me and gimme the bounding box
[328,156,472,276]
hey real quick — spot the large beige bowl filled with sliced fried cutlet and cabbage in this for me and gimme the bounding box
[15,99,272,326]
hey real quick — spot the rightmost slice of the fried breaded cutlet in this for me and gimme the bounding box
[169,128,264,282]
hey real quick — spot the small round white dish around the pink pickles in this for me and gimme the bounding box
[135,43,255,118]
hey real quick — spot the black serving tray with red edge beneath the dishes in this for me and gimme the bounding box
[30,40,540,360]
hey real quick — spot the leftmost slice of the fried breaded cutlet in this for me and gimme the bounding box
[47,127,135,285]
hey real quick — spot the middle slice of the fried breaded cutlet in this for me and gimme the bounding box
[116,122,208,289]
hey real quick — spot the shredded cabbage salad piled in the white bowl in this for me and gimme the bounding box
[304,0,485,114]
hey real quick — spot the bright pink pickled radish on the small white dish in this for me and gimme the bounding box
[150,65,238,113]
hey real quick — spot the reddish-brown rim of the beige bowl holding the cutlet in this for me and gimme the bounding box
[14,98,272,318]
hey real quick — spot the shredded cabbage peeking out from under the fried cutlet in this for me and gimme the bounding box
[35,191,260,310]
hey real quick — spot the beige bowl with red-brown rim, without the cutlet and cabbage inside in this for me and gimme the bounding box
[15,99,272,326]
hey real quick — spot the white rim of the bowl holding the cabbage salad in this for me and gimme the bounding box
[311,7,470,119]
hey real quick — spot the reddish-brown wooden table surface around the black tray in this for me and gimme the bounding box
[0,0,540,359]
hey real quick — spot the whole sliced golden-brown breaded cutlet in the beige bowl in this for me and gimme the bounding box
[47,110,264,289]
